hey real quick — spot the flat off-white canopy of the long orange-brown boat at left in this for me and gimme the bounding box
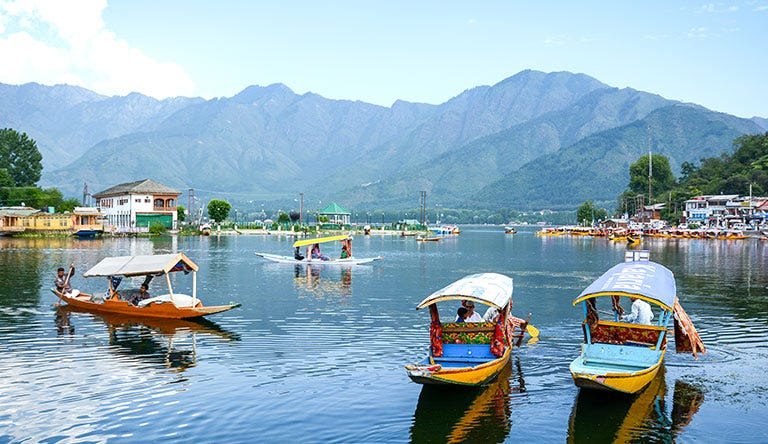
[83,253,198,277]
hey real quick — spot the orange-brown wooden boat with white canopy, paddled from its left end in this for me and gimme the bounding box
[51,253,240,319]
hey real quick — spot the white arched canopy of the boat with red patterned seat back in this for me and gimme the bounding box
[416,273,512,310]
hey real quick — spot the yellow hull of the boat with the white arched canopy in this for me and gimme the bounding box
[405,347,512,386]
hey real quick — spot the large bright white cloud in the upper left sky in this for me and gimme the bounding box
[0,0,195,98]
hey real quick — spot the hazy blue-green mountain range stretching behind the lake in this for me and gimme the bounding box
[0,71,768,209]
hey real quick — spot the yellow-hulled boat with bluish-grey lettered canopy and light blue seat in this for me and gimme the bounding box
[570,251,705,393]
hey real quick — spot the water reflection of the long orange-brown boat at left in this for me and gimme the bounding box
[56,305,240,372]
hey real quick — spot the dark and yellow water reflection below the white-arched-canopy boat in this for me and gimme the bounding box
[411,358,525,443]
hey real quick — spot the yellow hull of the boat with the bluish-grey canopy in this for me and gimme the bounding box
[570,351,664,394]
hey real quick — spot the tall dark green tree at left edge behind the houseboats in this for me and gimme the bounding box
[0,128,43,187]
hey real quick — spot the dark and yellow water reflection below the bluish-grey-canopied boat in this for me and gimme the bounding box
[568,366,704,443]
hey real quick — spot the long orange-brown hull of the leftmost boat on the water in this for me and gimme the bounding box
[53,290,240,319]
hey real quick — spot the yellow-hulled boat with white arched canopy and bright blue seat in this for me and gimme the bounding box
[405,273,527,386]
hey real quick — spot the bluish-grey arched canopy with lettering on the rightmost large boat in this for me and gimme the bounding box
[573,260,677,310]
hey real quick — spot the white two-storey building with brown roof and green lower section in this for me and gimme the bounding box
[93,179,181,232]
